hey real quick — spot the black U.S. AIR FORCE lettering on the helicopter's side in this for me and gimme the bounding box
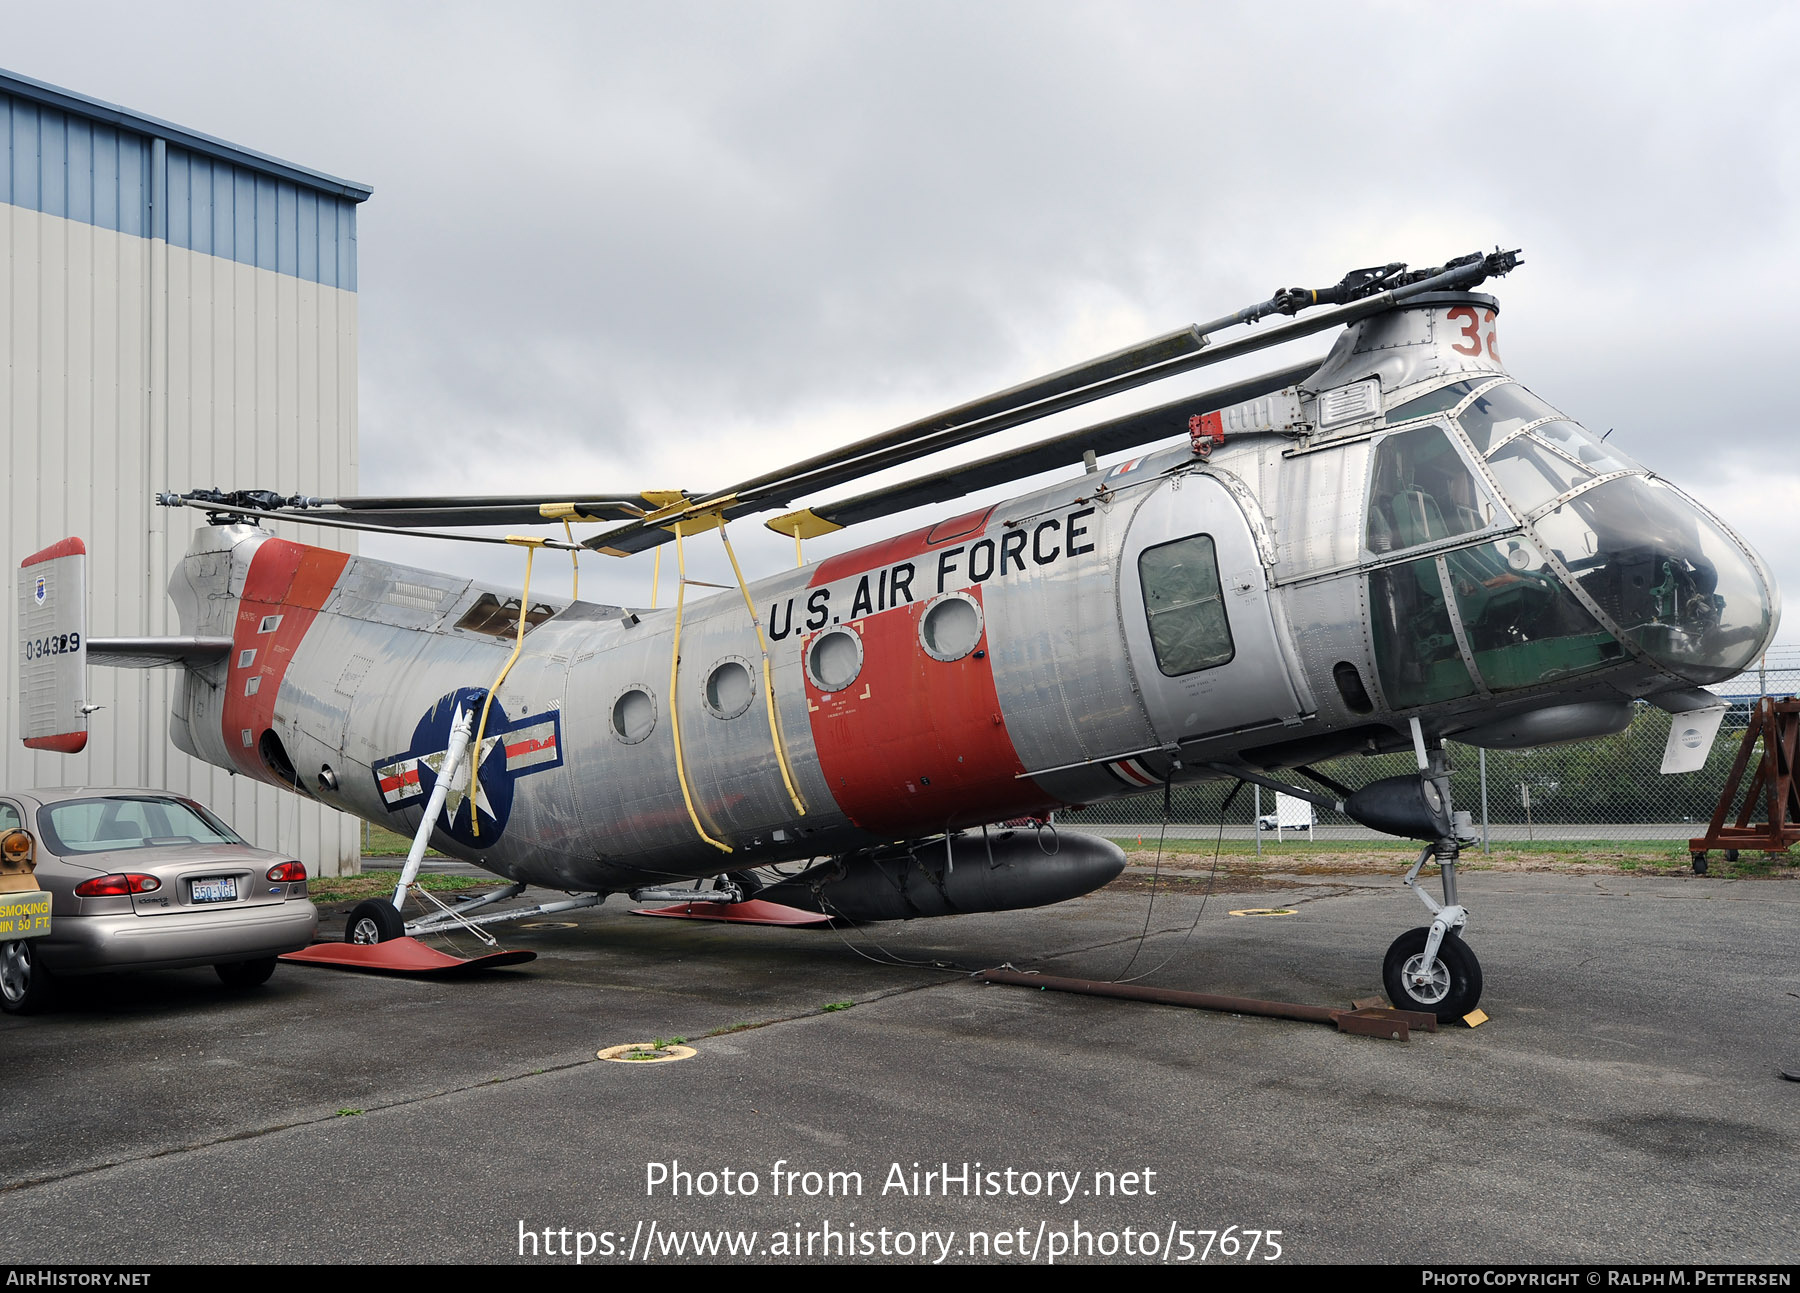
[769,508,1094,641]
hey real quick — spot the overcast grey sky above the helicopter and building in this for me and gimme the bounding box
[0,0,1800,641]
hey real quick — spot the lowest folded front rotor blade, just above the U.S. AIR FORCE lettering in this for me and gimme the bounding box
[763,355,1325,538]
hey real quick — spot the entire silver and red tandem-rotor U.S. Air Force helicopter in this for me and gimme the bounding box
[20,252,1778,1019]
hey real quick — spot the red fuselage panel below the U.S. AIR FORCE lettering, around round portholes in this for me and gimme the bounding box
[803,589,1055,836]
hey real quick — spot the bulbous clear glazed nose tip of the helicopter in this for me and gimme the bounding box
[1535,475,1780,684]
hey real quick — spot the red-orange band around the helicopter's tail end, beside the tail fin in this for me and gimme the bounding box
[220,538,349,785]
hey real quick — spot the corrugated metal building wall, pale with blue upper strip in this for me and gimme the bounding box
[0,83,360,873]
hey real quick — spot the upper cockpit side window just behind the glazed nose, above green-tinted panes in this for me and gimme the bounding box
[1364,425,1492,555]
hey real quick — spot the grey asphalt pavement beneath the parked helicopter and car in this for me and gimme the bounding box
[0,872,1800,1266]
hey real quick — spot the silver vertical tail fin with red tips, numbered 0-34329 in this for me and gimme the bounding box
[18,538,88,755]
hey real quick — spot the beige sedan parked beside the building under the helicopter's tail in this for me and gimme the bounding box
[0,789,319,1014]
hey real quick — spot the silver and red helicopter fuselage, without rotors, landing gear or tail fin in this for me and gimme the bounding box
[171,295,1777,891]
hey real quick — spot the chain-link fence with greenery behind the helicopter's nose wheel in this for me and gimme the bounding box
[1057,647,1800,848]
